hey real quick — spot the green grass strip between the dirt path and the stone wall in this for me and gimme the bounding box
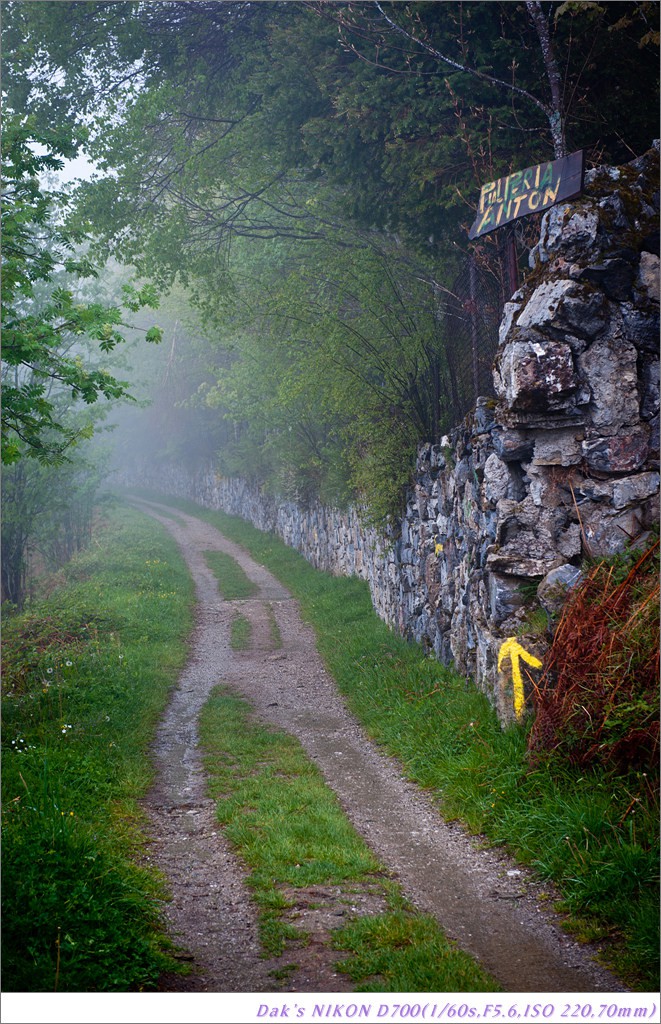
[126,497,659,990]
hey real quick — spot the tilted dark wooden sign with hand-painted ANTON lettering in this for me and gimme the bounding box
[469,150,583,239]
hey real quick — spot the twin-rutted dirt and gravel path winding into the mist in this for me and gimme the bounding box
[135,501,625,992]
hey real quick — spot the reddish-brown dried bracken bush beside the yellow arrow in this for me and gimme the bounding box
[528,540,659,779]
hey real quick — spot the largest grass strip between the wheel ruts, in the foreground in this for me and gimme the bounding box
[200,687,498,992]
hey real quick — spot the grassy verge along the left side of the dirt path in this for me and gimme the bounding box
[2,510,193,992]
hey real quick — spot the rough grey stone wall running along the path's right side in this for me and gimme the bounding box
[128,145,659,722]
